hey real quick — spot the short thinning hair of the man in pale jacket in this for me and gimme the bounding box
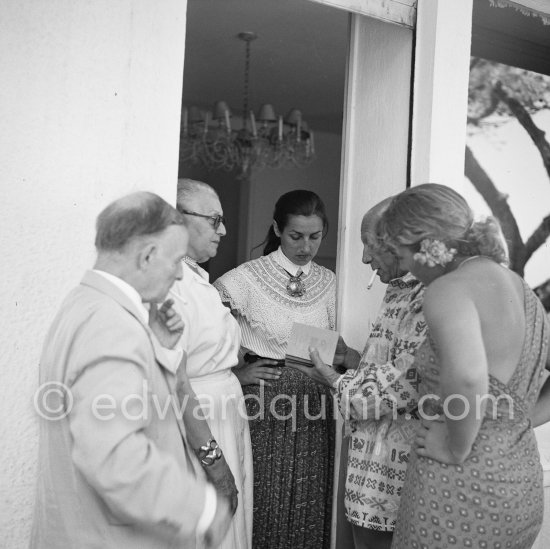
[95,191,183,251]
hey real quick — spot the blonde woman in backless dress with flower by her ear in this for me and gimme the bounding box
[381,184,550,549]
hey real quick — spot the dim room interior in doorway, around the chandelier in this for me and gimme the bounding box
[179,0,349,280]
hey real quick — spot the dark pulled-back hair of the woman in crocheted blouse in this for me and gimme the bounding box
[256,189,328,255]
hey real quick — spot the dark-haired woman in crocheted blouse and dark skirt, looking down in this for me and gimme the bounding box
[214,190,335,549]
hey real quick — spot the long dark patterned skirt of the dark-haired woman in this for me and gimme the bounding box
[243,367,335,549]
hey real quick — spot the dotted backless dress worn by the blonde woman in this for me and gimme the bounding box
[392,282,549,549]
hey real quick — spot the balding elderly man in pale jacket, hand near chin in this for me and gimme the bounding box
[31,192,231,549]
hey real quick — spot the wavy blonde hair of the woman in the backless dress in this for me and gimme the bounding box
[377,183,508,265]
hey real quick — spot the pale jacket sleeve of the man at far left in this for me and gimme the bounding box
[65,308,211,543]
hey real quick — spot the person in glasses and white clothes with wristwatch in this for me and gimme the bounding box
[170,179,252,549]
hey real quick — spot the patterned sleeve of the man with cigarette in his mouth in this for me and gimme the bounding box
[336,298,426,420]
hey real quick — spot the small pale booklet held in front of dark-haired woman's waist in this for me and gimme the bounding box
[285,322,339,367]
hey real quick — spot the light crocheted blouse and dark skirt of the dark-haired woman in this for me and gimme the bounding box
[214,252,336,549]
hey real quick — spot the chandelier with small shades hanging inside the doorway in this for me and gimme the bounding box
[180,32,315,175]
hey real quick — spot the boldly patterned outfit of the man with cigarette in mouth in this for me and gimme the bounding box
[336,275,426,531]
